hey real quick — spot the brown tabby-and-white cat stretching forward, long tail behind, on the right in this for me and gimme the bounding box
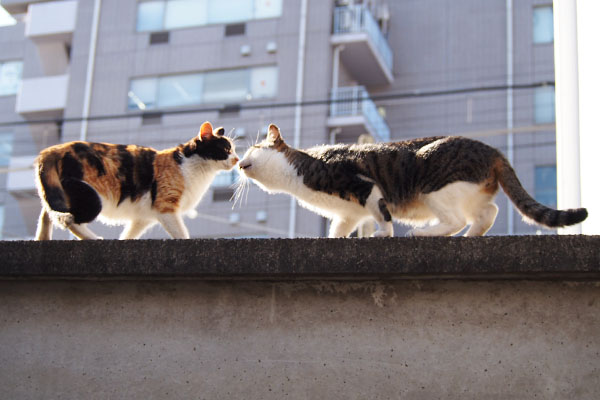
[239,124,587,237]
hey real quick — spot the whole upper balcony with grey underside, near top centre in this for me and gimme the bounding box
[331,4,394,86]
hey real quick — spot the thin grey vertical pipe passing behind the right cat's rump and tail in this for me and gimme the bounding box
[506,0,515,235]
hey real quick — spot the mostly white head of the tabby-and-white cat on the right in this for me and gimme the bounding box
[239,124,288,184]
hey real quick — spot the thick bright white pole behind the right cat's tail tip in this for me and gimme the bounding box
[554,0,581,234]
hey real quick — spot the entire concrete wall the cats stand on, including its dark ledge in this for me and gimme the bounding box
[0,236,600,399]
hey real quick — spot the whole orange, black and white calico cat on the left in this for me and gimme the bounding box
[35,122,238,240]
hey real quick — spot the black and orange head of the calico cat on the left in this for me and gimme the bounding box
[181,121,239,170]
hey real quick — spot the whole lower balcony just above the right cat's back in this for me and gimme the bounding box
[327,86,390,142]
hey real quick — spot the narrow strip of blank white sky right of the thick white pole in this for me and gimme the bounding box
[577,0,600,235]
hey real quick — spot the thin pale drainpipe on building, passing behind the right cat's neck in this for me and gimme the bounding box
[288,0,308,239]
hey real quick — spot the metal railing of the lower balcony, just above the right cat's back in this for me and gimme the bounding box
[329,86,390,142]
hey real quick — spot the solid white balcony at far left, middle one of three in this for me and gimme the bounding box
[16,75,69,118]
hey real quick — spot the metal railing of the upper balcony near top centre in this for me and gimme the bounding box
[333,4,393,70]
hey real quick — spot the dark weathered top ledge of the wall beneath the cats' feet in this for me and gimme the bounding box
[0,236,600,279]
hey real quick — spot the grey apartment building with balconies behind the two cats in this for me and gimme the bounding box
[0,0,556,239]
